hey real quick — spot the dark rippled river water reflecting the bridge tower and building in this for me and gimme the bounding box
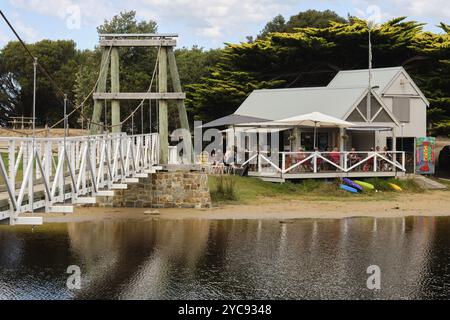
[0,217,450,299]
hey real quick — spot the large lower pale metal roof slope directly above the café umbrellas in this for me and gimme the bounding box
[235,87,367,120]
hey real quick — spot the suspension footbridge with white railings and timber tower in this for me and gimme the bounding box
[0,22,192,225]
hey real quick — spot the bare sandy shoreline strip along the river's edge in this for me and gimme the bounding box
[20,191,450,223]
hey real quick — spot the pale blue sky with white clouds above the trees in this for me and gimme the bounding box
[0,0,450,49]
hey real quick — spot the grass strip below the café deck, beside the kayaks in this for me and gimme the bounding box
[209,176,423,204]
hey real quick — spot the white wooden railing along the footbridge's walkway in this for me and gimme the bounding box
[0,133,159,224]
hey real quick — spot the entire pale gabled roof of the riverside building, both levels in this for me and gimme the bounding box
[234,67,429,125]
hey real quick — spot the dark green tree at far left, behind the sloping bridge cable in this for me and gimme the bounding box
[0,40,77,125]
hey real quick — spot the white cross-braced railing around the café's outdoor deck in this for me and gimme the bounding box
[242,151,406,175]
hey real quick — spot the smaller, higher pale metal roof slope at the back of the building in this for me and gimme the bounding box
[327,67,403,93]
